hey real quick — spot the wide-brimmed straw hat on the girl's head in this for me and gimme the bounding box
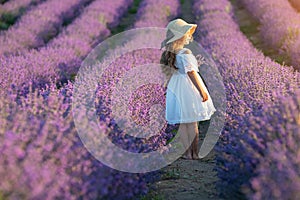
[160,18,197,49]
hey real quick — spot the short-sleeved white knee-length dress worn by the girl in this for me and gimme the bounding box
[165,48,216,124]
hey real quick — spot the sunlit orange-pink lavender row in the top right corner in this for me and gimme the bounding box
[241,0,300,70]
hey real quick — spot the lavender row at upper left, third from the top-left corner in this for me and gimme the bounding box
[0,0,113,95]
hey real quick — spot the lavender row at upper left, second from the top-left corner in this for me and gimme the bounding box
[0,0,91,56]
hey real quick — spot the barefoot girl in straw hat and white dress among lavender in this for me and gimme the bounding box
[160,19,216,160]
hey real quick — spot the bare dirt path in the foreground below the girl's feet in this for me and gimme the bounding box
[140,138,225,200]
